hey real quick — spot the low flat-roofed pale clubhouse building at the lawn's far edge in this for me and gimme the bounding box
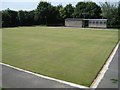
[65,18,107,28]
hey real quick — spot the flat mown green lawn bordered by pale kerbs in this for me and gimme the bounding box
[2,27,118,86]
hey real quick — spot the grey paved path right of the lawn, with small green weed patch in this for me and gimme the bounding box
[98,47,120,88]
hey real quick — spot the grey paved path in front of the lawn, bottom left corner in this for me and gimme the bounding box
[0,64,73,88]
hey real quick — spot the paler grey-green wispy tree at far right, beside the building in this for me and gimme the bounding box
[100,2,119,28]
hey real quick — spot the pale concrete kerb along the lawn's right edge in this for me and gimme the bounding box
[90,41,120,88]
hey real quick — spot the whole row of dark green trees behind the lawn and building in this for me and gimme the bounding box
[2,1,120,27]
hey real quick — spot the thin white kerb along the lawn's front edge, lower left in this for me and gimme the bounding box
[0,62,89,89]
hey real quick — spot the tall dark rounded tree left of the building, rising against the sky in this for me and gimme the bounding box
[35,2,60,25]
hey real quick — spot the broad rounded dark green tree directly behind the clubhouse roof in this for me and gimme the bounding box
[74,2,102,18]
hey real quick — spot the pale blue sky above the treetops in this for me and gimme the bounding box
[0,0,119,11]
